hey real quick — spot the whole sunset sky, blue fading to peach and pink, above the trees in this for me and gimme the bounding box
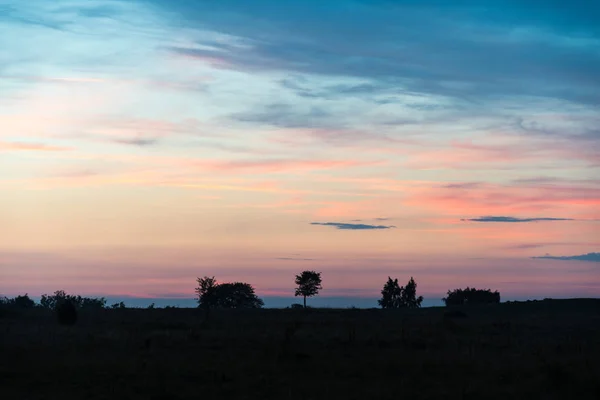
[0,0,600,305]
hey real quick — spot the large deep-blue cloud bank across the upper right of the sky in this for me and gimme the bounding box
[142,0,600,104]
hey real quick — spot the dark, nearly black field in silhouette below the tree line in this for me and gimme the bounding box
[0,300,600,400]
